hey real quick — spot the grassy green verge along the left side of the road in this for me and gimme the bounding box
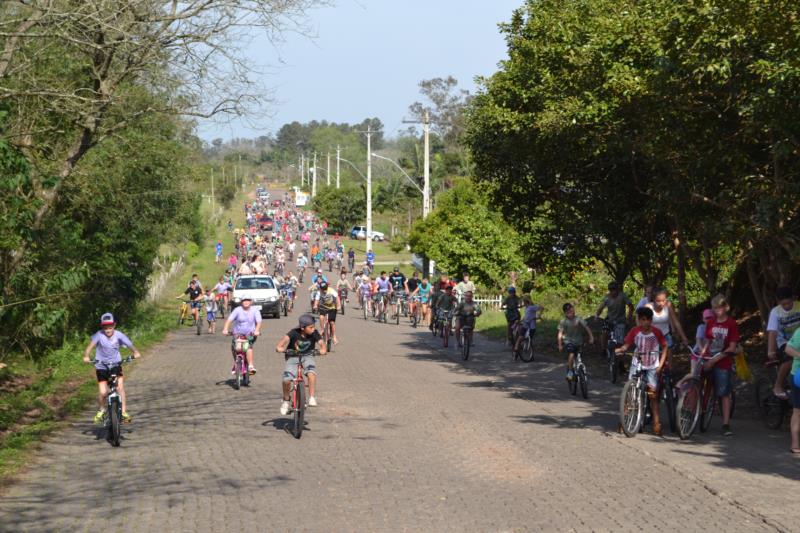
[0,194,245,485]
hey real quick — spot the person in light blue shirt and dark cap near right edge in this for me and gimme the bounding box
[767,287,800,400]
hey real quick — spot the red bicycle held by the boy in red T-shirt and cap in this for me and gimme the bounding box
[676,347,736,440]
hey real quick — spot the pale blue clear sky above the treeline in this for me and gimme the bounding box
[199,0,523,140]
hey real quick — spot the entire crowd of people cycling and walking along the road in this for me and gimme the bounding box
[84,186,800,455]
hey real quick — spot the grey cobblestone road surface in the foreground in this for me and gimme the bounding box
[0,274,800,533]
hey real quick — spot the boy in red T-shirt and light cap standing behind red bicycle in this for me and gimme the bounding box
[703,294,739,436]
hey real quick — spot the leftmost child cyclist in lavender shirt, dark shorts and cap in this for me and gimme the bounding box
[83,313,142,424]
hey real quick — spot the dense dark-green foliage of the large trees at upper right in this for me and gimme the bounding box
[466,0,800,311]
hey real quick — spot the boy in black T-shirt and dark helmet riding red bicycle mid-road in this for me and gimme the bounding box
[275,314,326,416]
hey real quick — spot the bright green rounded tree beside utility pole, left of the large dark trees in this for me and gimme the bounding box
[409,179,525,288]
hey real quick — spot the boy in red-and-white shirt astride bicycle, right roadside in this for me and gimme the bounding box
[614,307,669,437]
